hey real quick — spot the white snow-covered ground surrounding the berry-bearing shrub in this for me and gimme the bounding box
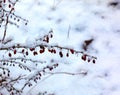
[1,0,120,95]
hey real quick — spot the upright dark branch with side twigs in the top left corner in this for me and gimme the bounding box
[0,0,28,42]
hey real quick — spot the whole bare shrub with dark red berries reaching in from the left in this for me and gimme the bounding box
[0,0,96,95]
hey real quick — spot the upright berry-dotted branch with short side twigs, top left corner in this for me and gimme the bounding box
[0,0,28,42]
